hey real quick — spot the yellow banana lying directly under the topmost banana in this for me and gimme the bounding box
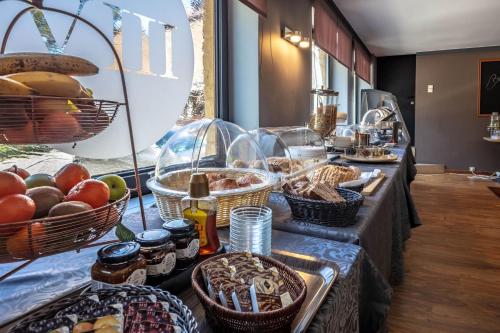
[5,72,82,97]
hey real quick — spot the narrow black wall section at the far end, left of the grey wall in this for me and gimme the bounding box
[377,55,416,145]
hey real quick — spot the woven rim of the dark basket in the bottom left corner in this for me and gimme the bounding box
[9,285,199,333]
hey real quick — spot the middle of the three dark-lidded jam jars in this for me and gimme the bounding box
[135,229,175,281]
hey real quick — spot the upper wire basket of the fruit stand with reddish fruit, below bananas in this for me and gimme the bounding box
[0,96,123,144]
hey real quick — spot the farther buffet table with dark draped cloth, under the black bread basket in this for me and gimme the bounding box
[269,144,420,285]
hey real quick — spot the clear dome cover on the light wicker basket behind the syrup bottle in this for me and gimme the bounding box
[148,119,273,194]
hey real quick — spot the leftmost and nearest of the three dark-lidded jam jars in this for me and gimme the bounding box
[91,242,146,288]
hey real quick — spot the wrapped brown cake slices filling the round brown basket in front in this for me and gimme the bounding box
[201,252,293,313]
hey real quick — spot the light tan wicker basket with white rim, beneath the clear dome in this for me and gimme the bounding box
[147,168,274,227]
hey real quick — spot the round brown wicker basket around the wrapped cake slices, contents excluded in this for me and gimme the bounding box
[191,253,307,332]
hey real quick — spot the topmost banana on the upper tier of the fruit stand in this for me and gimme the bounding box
[0,53,99,76]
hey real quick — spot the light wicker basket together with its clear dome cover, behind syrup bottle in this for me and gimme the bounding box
[147,119,276,227]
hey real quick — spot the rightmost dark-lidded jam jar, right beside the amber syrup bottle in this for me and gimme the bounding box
[163,219,200,268]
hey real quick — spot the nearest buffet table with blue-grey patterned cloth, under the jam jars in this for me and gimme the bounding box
[0,200,392,332]
